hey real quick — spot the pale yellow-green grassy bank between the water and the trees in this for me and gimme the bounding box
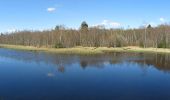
[0,44,170,55]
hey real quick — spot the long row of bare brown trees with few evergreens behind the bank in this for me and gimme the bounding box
[0,22,170,48]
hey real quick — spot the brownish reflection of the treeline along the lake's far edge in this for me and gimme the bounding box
[0,49,170,73]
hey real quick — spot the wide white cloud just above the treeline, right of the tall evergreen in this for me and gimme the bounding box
[94,20,121,28]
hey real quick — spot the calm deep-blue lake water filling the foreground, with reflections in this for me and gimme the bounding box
[0,49,170,100]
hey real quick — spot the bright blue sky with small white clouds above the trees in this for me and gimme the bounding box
[0,0,170,32]
